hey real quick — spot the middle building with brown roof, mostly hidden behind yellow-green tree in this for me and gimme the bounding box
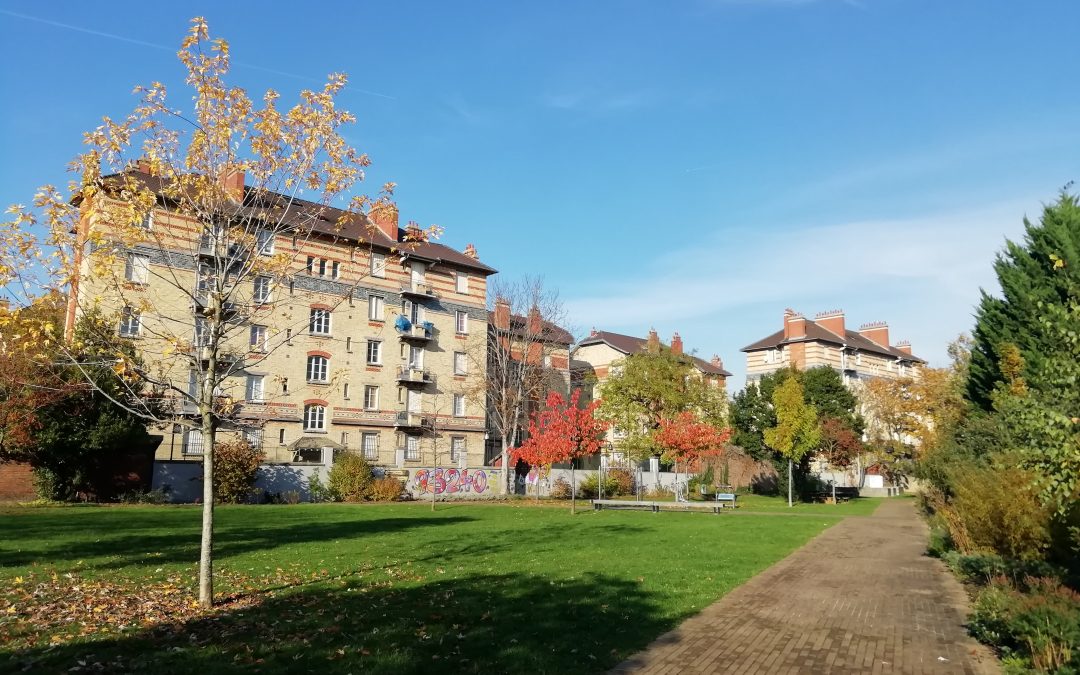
[573,329,731,461]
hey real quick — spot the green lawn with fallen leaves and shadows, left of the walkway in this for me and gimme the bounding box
[0,498,859,675]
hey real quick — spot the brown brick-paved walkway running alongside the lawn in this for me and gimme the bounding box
[612,499,999,675]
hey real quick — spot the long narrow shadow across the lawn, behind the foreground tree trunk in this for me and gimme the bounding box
[0,511,474,569]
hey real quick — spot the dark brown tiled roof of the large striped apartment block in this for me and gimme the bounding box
[104,168,498,275]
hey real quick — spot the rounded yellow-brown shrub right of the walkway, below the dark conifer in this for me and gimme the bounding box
[943,467,1051,559]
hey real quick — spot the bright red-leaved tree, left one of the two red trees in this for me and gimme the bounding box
[512,391,607,513]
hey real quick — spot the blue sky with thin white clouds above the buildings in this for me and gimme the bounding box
[0,0,1080,391]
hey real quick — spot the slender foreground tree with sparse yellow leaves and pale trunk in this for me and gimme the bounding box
[0,18,437,605]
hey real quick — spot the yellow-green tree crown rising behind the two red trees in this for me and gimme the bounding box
[598,346,727,461]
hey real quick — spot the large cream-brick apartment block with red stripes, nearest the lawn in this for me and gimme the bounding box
[68,167,496,470]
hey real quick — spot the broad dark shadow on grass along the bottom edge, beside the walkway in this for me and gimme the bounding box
[8,573,681,675]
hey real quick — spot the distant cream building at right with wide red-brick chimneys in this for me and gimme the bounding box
[742,309,926,384]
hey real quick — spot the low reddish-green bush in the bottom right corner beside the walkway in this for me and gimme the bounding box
[969,578,1080,675]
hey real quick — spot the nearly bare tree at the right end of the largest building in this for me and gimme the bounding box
[470,276,573,495]
